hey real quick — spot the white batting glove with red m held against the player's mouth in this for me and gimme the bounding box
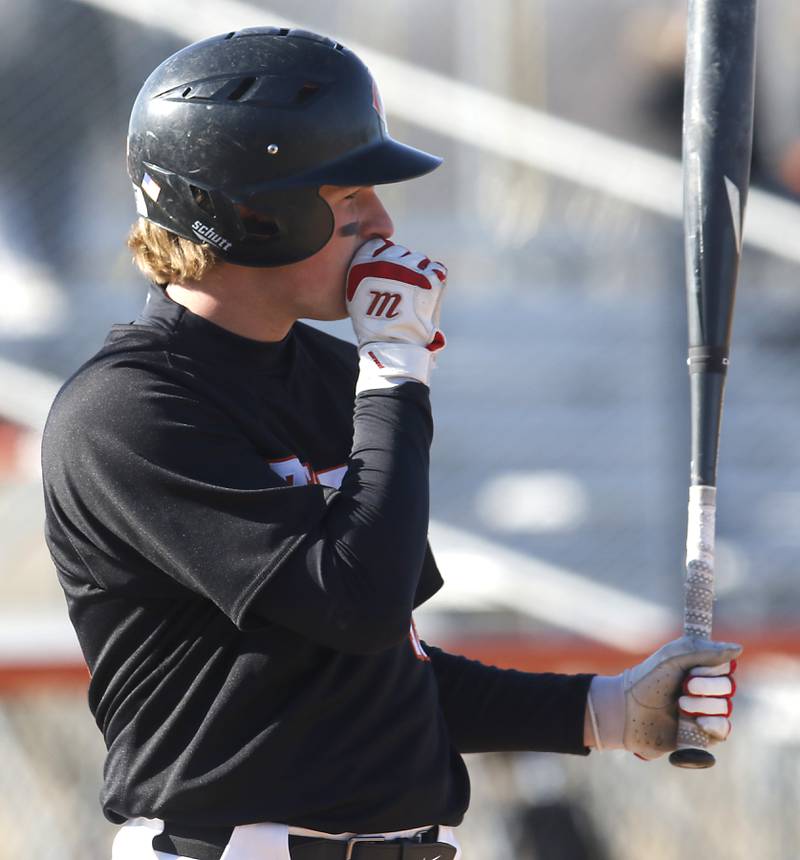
[347,239,447,394]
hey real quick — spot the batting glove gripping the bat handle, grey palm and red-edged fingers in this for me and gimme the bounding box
[587,636,742,760]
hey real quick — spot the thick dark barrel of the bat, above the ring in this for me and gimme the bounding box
[683,0,756,351]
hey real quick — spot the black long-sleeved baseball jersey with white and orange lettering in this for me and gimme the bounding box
[43,288,589,832]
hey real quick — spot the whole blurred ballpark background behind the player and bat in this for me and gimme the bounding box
[0,0,800,860]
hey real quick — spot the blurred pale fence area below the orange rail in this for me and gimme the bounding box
[0,664,800,860]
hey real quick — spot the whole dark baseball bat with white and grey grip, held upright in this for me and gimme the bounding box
[670,0,756,768]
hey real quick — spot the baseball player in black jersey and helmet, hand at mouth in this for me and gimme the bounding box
[43,28,740,860]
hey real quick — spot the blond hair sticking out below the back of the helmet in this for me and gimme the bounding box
[128,218,219,286]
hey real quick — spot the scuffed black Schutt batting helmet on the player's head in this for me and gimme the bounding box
[128,27,441,266]
